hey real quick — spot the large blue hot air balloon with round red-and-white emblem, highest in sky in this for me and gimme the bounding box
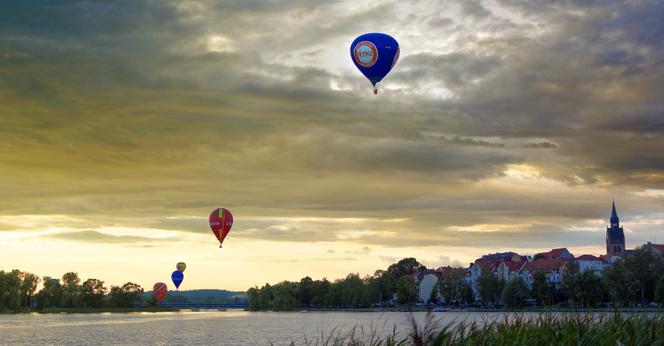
[350,33,400,93]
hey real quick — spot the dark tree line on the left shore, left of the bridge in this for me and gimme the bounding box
[0,270,143,312]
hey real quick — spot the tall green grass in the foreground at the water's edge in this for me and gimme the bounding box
[292,313,664,346]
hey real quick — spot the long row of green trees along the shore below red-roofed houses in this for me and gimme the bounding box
[247,247,664,311]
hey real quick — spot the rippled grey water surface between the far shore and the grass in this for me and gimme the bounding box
[0,310,564,345]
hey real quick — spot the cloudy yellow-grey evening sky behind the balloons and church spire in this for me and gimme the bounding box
[0,0,664,290]
